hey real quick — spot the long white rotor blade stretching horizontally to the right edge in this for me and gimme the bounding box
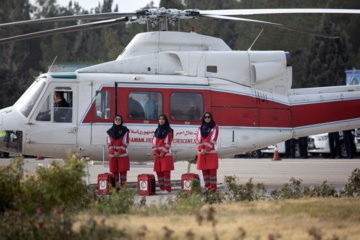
[199,8,360,16]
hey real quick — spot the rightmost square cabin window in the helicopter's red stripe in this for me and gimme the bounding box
[170,92,204,121]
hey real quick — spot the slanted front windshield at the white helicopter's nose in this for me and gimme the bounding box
[14,82,45,117]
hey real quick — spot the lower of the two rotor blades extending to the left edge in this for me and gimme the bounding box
[0,17,128,44]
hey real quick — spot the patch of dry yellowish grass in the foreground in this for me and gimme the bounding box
[74,197,360,240]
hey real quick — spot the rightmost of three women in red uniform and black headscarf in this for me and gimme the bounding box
[196,112,219,191]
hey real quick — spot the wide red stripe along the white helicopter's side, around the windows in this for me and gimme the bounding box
[82,87,360,128]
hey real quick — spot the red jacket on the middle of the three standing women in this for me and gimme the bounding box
[152,131,174,172]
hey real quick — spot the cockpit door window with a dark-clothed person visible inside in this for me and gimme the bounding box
[36,87,73,123]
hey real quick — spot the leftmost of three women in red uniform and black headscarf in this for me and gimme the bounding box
[106,115,130,186]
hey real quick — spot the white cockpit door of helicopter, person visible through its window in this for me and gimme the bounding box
[27,83,77,145]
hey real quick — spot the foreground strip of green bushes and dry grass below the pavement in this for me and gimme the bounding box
[0,155,360,240]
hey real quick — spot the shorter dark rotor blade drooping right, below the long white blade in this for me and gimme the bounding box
[201,15,339,39]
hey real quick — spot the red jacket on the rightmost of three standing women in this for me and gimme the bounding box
[196,126,219,170]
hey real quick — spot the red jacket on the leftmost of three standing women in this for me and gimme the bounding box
[106,132,130,171]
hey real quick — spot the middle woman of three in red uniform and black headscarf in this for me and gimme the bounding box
[152,114,174,194]
